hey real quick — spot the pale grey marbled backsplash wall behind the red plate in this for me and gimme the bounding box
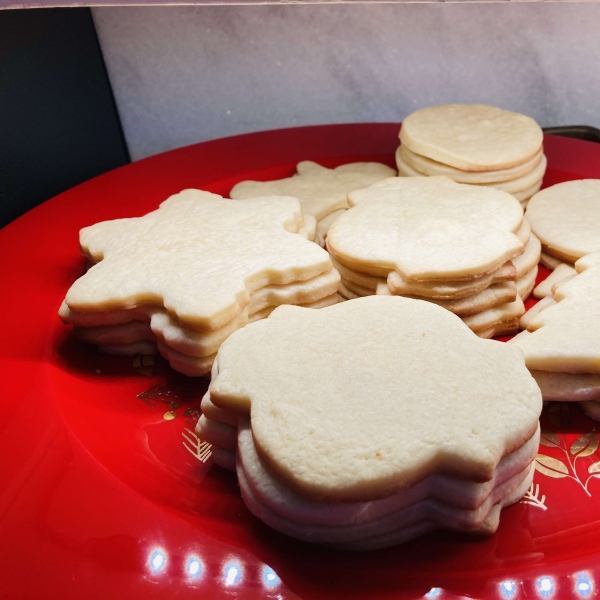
[93,3,600,159]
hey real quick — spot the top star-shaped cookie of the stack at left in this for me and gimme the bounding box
[65,190,331,330]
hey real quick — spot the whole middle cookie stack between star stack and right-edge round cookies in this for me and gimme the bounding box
[327,177,540,337]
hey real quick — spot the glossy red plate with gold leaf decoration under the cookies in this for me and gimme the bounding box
[0,124,600,600]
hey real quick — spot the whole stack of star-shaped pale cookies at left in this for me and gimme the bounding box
[59,190,340,375]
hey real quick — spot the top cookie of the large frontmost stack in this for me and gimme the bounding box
[210,296,541,501]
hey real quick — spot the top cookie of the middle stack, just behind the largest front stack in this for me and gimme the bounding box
[327,177,523,282]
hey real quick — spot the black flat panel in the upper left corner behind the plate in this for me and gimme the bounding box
[0,8,130,227]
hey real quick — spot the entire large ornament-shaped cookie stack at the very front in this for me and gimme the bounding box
[198,296,542,550]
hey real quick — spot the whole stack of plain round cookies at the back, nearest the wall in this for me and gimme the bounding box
[396,104,547,211]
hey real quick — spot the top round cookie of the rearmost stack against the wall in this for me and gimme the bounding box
[400,104,543,171]
